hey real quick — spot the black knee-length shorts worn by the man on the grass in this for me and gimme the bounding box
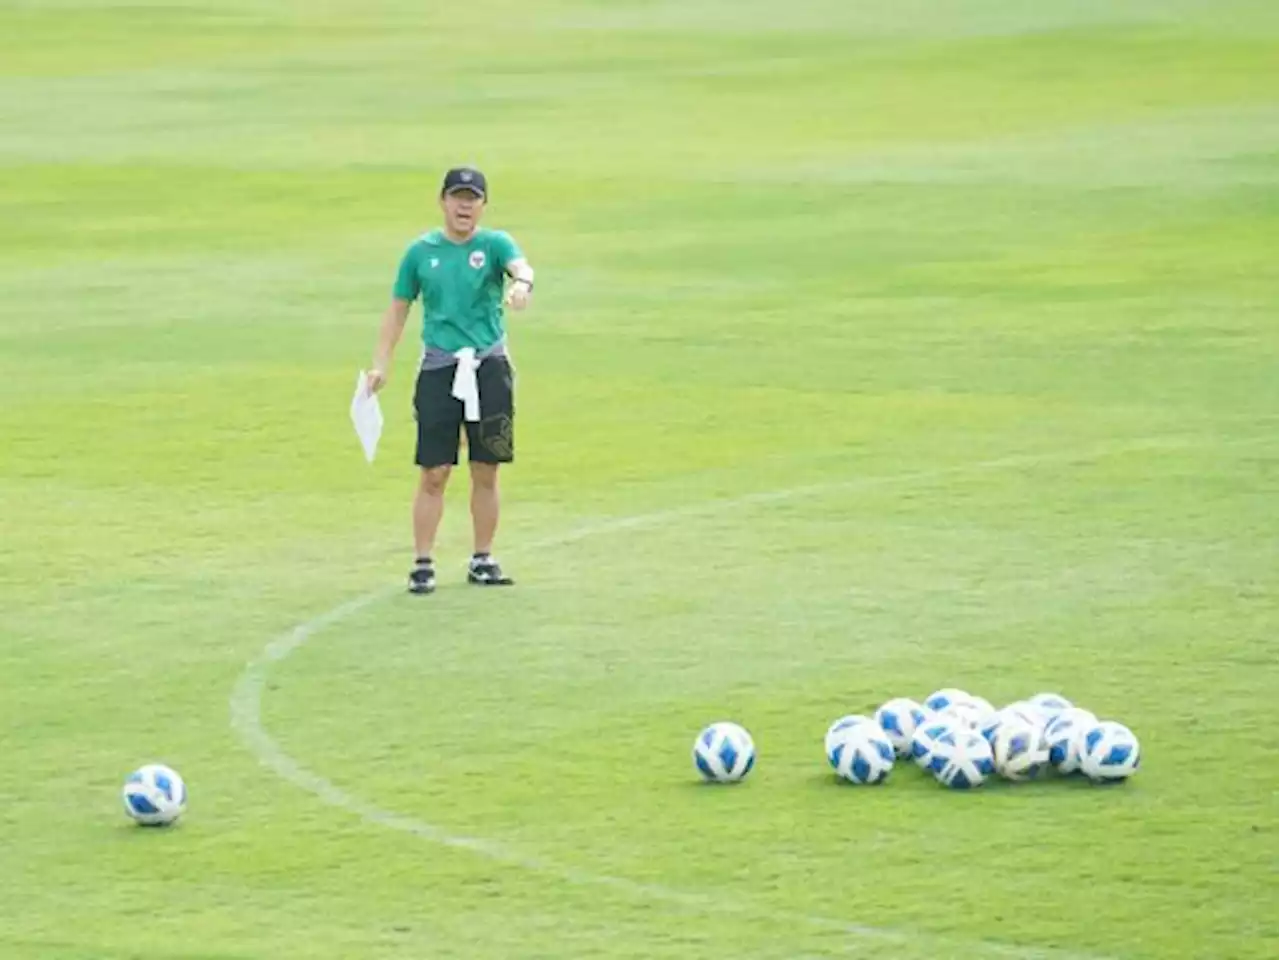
[413,357,516,467]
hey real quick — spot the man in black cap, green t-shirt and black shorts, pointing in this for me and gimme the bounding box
[369,166,534,594]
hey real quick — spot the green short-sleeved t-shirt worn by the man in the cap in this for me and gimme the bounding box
[394,230,524,353]
